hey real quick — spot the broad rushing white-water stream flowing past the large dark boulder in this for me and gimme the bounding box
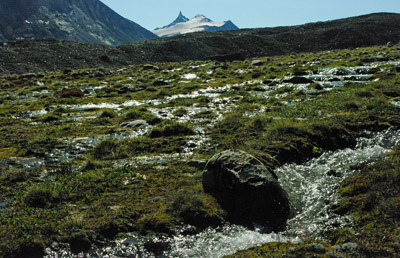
[46,130,400,258]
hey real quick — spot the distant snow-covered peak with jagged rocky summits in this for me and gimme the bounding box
[152,12,239,37]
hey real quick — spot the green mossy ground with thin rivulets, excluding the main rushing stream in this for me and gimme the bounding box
[0,45,400,257]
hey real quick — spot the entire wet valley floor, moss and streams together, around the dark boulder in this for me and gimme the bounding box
[0,41,400,257]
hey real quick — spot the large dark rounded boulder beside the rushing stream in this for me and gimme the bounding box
[203,150,290,231]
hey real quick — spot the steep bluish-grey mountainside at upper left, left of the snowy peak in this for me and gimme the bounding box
[0,0,157,45]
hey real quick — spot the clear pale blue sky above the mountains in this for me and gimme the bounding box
[101,0,400,30]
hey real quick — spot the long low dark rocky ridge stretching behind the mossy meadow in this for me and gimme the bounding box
[0,13,400,74]
